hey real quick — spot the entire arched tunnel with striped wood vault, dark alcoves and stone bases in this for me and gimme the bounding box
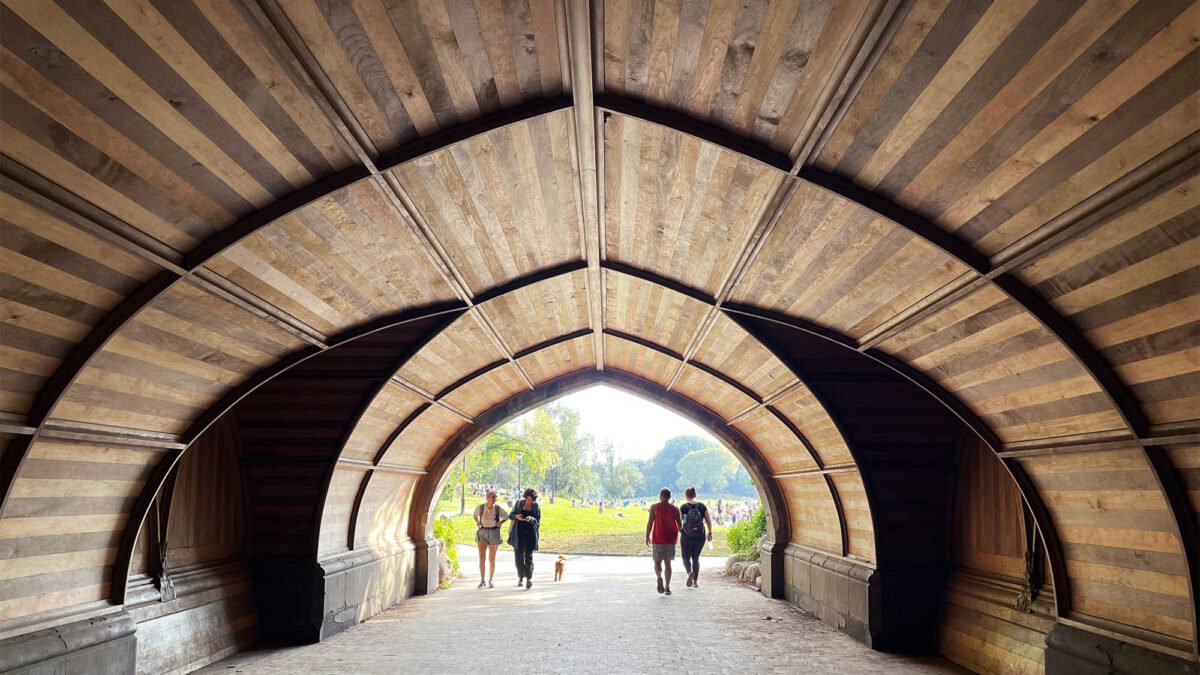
[0,0,1200,675]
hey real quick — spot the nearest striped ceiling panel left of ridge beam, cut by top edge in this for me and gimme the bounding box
[268,0,565,151]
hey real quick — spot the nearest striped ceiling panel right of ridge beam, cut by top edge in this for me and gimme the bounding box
[602,0,869,153]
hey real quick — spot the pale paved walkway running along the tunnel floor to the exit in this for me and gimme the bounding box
[200,549,964,675]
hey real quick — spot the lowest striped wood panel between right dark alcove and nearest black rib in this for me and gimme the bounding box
[1019,448,1194,638]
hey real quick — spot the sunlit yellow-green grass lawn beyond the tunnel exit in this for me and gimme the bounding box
[438,498,733,556]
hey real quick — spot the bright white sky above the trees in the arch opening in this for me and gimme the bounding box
[549,384,720,459]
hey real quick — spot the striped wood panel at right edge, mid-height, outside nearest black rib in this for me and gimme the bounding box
[1014,170,1200,424]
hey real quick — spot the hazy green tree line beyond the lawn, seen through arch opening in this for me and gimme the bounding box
[445,404,757,498]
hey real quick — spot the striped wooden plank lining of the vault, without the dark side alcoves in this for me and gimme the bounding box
[0,0,1200,652]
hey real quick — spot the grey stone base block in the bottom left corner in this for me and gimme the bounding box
[0,611,138,675]
